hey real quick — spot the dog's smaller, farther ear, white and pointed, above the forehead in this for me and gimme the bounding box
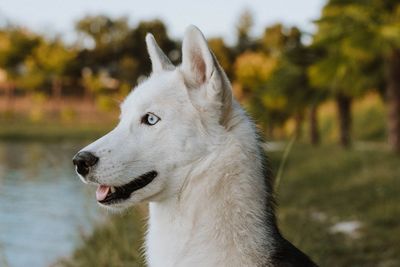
[146,33,175,72]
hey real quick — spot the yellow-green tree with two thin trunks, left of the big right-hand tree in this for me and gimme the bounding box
[261,27,322,144]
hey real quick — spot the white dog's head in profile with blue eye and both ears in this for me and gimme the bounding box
[73,26,232,208]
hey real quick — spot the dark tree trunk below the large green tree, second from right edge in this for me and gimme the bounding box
[336,94,351,148]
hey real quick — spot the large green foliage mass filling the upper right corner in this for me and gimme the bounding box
[309,0,400,96]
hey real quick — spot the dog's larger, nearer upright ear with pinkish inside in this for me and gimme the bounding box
[182,25,232,124]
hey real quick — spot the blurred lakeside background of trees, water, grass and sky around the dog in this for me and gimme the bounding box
[0,0,400,267]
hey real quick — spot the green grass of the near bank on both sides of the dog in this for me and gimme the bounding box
[59,144,400,267]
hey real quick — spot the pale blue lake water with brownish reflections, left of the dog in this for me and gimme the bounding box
[0,142,105,267]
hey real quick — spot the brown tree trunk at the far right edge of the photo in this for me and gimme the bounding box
[386,50,400,153]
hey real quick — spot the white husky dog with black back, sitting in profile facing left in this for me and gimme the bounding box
[73,26,315,267]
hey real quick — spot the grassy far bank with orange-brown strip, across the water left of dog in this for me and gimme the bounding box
[0,96,118,142]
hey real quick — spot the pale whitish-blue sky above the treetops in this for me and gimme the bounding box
[0,0,326,43]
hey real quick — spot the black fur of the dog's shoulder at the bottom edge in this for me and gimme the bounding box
[271,237,318,267]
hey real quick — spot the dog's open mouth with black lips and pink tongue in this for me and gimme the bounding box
[96,171,158,205]
